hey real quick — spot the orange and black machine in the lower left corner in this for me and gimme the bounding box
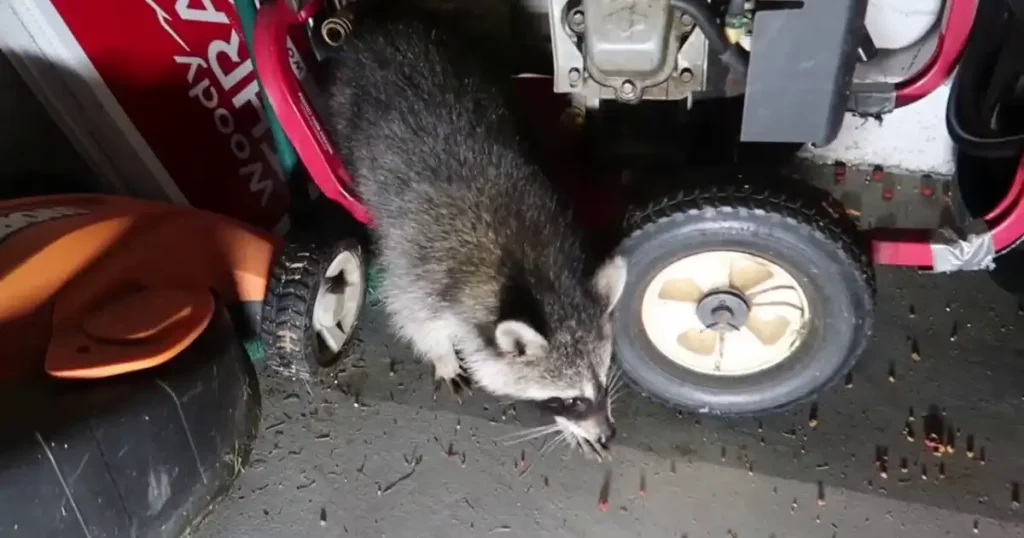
[0,194,266,538]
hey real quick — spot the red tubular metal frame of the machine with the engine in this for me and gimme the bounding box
[254,0,1024,268]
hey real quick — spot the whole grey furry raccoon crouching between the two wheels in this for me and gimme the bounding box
[319,13,627,455]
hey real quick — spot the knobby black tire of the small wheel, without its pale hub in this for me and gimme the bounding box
[260,234,366,379]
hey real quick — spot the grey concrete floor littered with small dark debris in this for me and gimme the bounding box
[195,270,1024,538]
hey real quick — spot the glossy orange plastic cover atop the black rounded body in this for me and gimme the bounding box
[0,195,280,382]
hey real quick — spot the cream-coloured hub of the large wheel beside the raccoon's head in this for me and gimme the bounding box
[640,251,811,376]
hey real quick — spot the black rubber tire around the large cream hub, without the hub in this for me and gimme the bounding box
[612,182,874,415]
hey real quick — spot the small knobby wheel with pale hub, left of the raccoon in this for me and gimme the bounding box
[260,237,367,379]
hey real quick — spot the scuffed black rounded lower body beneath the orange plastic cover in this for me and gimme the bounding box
[0,304,262,538]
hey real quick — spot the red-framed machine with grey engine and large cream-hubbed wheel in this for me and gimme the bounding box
[252,0,1024,415]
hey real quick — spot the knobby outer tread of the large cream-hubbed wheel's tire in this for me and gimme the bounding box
[623,184,878,417]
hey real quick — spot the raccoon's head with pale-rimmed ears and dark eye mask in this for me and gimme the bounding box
[472,256,626,456]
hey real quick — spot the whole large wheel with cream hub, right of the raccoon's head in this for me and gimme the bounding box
[612,187,874,415]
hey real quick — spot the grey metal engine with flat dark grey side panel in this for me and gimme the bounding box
[525,0,873,146]
